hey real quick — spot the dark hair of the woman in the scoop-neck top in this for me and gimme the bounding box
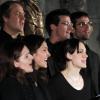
[53,38,83,70]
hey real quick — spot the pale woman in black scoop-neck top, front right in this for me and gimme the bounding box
[48,38,91,100]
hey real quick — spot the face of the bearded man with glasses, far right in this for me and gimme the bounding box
[75,16,93,40]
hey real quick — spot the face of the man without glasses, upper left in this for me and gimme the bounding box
[4,4,25,34]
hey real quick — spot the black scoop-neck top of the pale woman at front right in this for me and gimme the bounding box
[48,73,91,100]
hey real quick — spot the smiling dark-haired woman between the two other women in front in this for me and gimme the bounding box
[23,34,50,100]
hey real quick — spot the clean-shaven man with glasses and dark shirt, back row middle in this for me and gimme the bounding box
[45,9,72,77]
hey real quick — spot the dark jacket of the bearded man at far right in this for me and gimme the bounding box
[86,45,100,96]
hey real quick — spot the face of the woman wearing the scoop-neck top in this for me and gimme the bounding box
[67,42,88,69]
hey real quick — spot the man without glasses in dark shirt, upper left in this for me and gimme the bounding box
[0,1,25,45]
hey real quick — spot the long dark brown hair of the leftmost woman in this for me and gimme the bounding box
[0,39,25,82]
